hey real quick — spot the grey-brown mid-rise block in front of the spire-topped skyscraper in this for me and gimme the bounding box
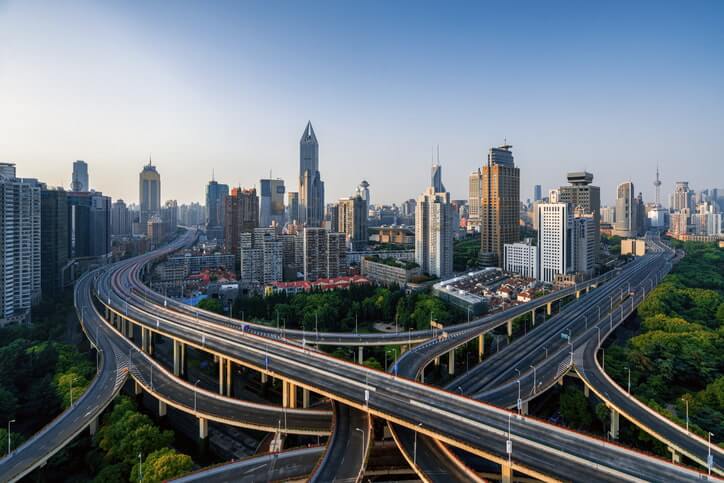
[301,227,346,281]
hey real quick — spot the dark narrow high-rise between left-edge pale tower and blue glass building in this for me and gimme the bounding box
[40,184,68,299]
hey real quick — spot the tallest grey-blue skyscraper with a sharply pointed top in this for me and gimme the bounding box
[299,122,324,227]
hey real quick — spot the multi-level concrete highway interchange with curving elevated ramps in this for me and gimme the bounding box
[0,230,724,482]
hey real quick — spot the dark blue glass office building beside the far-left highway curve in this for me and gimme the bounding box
[68,191,111,258]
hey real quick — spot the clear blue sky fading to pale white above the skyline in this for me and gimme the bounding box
[0,0,724,204]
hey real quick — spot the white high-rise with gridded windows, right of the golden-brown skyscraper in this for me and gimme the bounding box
[538,203,575,283]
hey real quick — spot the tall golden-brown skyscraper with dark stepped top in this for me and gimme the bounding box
[480,144,520,266]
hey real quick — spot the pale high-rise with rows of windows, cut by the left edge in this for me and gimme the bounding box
[0,163,41,327]
